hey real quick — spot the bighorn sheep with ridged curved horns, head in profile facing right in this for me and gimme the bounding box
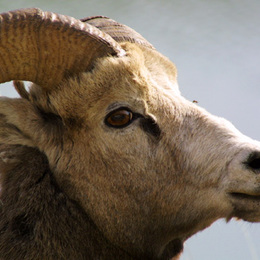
[0,9,260,259]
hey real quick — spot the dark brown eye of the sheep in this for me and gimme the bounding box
[105,109,133,128]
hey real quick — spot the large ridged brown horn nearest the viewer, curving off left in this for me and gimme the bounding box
[0,8,124,89]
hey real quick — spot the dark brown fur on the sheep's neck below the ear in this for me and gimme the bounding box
[0,145,136,259]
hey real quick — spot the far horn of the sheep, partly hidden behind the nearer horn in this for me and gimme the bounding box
[81,16,154,49]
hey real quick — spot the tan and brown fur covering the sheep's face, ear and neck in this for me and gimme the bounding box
[0,39,260,259]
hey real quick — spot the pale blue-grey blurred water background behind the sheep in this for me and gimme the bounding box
[0,0,260,260]
